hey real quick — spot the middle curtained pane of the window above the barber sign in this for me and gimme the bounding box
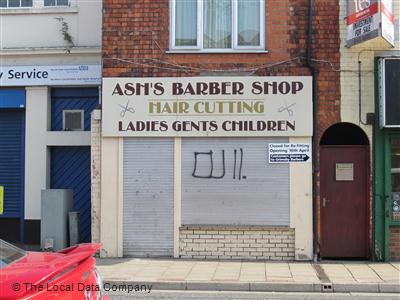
[203,0,232,48]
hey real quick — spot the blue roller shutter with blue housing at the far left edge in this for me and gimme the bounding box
[0,89,25,240]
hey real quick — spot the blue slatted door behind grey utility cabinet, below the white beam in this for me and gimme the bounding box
[50,146,91,242]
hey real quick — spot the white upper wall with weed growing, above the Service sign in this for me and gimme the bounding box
[0,0,102,49]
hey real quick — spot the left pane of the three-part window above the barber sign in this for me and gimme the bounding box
[175,0,197,46]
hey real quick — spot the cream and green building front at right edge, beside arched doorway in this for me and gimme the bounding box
[339,1,400,261]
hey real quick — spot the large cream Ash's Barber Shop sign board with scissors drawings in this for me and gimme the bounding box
[102,76,312,136]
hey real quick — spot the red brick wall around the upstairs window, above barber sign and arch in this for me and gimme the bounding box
[103,0,340,255]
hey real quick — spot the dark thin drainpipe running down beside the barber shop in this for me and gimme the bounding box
[307,0,318,262]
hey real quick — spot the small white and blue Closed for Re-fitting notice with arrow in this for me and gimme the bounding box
[268,143,311,164]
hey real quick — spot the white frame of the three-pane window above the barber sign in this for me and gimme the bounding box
[169,0,266,53]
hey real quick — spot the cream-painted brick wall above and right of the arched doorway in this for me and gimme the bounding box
[339,0,400,137]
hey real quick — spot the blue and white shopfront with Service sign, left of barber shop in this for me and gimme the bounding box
[0,65,101,244]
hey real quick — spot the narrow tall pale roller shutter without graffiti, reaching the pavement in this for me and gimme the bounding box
[123,138,174,257]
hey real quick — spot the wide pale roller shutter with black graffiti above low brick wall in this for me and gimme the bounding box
[182,138,289,226]
